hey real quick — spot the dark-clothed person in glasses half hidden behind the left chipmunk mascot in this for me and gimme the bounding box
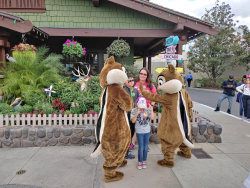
[124,75,139,159]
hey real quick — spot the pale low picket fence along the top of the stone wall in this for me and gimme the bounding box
[0,110,199,127]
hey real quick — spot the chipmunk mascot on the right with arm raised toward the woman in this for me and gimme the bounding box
[140,64,194,168]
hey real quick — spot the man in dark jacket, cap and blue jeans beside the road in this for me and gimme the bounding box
[214,74,237,114]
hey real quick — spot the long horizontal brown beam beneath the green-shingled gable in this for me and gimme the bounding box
[39,27,174,38]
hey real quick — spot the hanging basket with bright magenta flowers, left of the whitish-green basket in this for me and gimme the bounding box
[62,39,86,57]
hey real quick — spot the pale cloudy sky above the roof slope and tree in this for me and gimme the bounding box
[150,0,250,28]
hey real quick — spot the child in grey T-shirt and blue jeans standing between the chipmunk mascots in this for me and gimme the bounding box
[130,97,154,170]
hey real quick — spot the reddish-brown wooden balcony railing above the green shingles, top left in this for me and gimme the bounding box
[0,0,45,9]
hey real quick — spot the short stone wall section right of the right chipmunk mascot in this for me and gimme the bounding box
[191,117,222,143]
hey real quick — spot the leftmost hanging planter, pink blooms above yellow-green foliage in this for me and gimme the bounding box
[12,43,37,65]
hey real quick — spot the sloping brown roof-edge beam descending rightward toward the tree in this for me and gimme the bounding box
[108,0,220,35]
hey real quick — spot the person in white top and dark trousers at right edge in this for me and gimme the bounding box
[236,75,250,123]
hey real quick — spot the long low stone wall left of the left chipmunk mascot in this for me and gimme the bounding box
[0,125,96,148]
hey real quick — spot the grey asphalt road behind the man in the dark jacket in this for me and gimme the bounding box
[187,88,240,117]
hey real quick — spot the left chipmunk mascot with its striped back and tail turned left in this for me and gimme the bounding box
[91,56,134,182]
